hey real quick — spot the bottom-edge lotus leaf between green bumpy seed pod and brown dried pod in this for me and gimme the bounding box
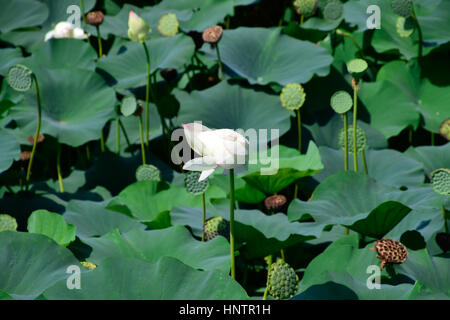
[294,235,413,300]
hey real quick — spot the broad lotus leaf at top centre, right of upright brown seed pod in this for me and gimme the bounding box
[203,27,333,85]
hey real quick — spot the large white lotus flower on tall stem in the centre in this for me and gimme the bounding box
[183,123,248,181]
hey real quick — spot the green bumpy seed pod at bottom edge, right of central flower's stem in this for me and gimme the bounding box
[267,259,298,300]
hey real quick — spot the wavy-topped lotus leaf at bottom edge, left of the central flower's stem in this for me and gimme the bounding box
[44,257,248,300]
